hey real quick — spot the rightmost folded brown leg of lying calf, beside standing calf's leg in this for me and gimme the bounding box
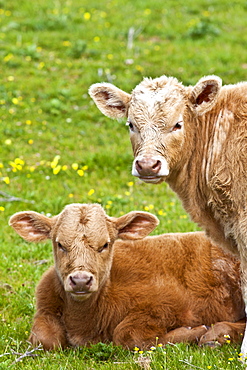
[199,319,245,347]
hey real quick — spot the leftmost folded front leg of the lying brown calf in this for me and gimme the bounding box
[29,316,68,350]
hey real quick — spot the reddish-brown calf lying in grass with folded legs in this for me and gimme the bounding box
[10,204,245,350]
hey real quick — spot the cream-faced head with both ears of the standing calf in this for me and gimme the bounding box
[89,76,221,183]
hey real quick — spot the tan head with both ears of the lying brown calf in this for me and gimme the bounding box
[9,204,158,300]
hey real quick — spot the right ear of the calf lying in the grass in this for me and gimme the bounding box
[115,211,159,240]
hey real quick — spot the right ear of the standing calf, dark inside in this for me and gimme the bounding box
[190,76,222,114]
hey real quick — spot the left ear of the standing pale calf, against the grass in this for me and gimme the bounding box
[88,83,130,118]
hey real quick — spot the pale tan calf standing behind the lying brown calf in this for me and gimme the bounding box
[89,76,247,356]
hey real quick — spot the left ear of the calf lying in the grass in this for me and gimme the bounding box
[9,211,54,242]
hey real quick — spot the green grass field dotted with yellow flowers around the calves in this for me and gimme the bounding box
[0,0,247,370]
